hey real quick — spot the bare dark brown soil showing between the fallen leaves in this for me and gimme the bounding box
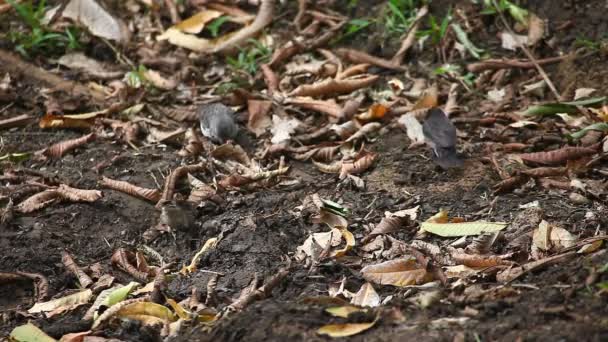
[0,0,608,341]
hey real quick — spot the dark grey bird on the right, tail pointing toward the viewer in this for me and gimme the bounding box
[422,108,464,169]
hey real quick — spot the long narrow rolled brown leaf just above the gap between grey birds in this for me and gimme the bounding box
[289,75,379,97]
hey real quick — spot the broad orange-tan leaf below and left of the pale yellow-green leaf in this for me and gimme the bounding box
[361,257,433,287]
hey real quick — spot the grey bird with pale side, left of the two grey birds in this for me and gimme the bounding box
[198,103,239,144]
